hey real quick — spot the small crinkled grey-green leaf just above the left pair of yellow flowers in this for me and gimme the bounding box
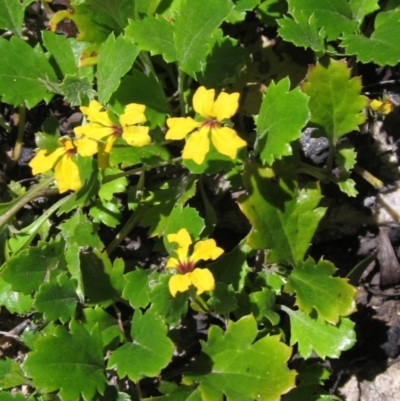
[59,75,96,106]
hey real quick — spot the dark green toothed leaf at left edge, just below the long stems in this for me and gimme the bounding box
[1,241,66,294]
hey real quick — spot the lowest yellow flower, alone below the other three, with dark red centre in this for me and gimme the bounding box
[166,228,224,297]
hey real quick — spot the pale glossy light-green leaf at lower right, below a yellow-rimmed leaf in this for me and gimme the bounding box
[282,307,356,359]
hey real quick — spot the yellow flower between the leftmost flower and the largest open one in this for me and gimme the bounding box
[74,100,151,168]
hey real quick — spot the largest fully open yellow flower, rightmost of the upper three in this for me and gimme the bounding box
[165,86,246,164]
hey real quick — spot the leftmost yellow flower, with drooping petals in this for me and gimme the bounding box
[29,137,82,193]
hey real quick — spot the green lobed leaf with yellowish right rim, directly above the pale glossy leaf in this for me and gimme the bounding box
[285,257,357,324]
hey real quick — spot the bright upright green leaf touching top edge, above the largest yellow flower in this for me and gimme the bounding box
[174,0,233,76]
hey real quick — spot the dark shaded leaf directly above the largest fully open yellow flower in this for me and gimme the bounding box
[198,29,248,88]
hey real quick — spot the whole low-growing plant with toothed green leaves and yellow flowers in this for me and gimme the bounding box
[0,0,394,401]
